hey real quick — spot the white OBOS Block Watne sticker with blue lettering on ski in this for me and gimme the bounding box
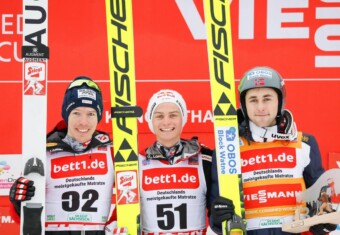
[217,127,241,174]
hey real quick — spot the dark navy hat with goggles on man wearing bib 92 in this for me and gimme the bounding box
[61,76,103,123]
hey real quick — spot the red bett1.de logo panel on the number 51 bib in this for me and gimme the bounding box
[141,166,200,191]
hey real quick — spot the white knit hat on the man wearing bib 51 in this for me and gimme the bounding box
[145,90,188,133]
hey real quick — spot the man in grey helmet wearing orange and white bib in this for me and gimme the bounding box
[210,67,336,235]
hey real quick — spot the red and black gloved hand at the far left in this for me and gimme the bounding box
[9,177,35,215]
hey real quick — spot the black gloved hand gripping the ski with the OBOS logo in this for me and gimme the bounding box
[211,197,235,224]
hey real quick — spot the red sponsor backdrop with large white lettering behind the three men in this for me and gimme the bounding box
[0,0,340,234]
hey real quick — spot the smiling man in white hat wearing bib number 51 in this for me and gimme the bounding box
[139,90,212,235]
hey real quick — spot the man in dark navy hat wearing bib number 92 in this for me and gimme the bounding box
[10,76,127,235]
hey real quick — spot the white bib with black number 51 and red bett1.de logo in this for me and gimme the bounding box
[139,154,207,233]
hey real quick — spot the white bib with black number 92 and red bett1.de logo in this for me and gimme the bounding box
[46,146,114,231]
